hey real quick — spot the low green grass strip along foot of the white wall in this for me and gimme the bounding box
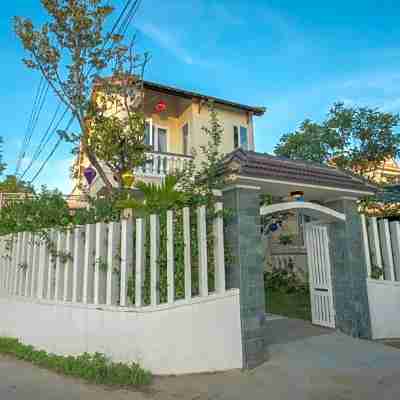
[0,337,151,386]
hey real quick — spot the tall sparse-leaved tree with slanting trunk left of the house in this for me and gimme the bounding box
[14,0,148,190]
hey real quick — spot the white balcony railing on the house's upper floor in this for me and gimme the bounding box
[135,152,193,177]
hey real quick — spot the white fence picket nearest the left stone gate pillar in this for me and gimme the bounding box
[213,202,226,293]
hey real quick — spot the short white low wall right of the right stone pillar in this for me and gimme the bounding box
[367,279,400,339]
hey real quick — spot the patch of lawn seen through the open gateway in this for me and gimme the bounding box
[265,288,311,321]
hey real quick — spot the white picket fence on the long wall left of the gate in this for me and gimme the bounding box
[0,203,226,308]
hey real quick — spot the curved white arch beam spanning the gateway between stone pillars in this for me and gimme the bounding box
[260,201,346,222]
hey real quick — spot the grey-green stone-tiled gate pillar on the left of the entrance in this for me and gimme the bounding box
[223,185,266,368]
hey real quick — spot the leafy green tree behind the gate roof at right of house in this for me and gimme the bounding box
[275,103,400,174]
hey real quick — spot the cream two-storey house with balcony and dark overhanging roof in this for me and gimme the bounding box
[73,81,266,194]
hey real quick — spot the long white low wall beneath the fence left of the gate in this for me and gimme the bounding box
[0,290,243,375]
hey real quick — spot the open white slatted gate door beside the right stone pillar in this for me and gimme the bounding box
[305,222,335,328]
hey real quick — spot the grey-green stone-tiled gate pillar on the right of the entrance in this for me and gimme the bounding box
[327,198,371,339]
